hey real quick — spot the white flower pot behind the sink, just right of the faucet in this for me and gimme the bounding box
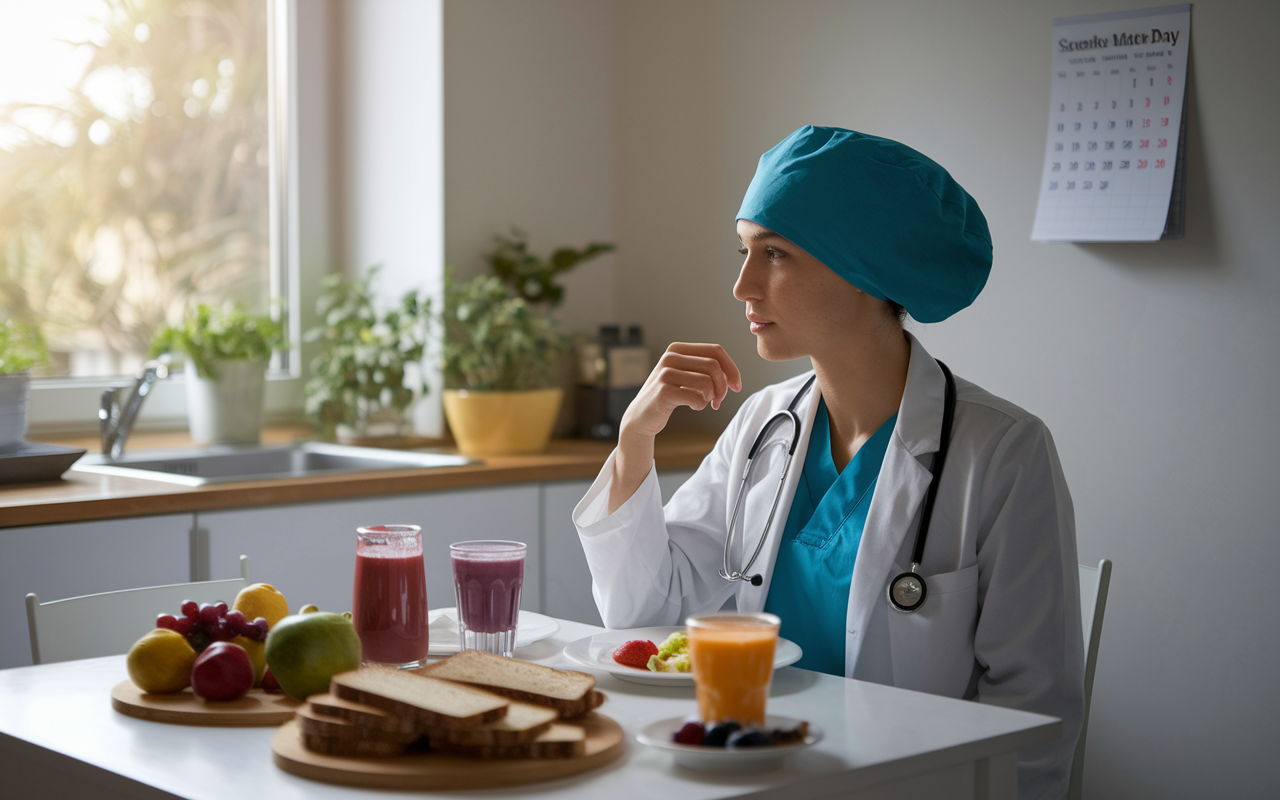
[186,361,266,444]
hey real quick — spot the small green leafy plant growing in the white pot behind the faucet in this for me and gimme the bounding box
[151,303,284,378]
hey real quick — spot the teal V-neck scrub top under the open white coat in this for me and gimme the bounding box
[764,401,897,676]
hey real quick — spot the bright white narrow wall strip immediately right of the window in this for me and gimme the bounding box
[330,0,444,435]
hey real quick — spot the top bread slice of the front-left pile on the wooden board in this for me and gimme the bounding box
[329,667,511,730]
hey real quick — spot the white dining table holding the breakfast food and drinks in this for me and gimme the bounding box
[0,621,1061,800]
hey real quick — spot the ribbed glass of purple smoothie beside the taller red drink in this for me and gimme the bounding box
[449,539,527,658]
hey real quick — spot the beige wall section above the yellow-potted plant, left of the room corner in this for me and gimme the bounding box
[444,0,616,332]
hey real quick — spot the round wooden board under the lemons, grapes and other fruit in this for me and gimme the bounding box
[111,681,302,728]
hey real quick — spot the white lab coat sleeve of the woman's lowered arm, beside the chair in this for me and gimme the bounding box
[974,417,1084,799]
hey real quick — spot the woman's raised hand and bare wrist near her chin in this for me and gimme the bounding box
[609,342,742,513]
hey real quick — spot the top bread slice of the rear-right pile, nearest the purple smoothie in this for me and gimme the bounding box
[416,650,604,718]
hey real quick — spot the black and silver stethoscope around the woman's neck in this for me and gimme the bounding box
[719,361,956,613]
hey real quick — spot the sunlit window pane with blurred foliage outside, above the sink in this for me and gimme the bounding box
[0,0,289,381]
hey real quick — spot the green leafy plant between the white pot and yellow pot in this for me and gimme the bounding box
[305,266,431,438]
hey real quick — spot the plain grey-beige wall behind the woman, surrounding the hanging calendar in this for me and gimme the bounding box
[445,0,1280,799]
